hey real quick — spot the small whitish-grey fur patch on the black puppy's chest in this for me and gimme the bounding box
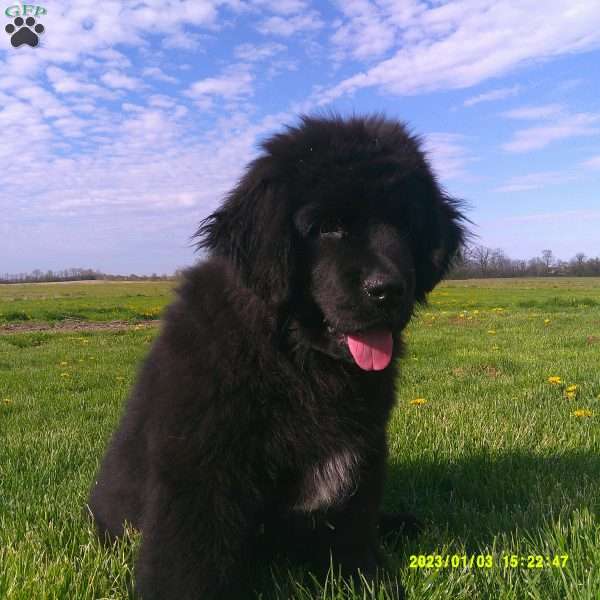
[293,448,362,512]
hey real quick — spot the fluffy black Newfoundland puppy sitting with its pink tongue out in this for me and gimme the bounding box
[89,116,464,600]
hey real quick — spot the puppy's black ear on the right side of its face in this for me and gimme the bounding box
[416,196,467,302]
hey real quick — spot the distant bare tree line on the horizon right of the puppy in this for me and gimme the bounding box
[449,246,600,279]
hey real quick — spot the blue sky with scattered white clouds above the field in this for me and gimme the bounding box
[0,0,600,273]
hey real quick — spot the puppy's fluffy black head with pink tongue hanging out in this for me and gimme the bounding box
[198,112,464,370]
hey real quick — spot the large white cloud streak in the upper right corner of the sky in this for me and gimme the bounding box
[319,0,600,104]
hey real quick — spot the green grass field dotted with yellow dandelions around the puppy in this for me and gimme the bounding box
[0,279,600,600]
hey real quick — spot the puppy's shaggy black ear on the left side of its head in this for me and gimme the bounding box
[195,159,293,305]
